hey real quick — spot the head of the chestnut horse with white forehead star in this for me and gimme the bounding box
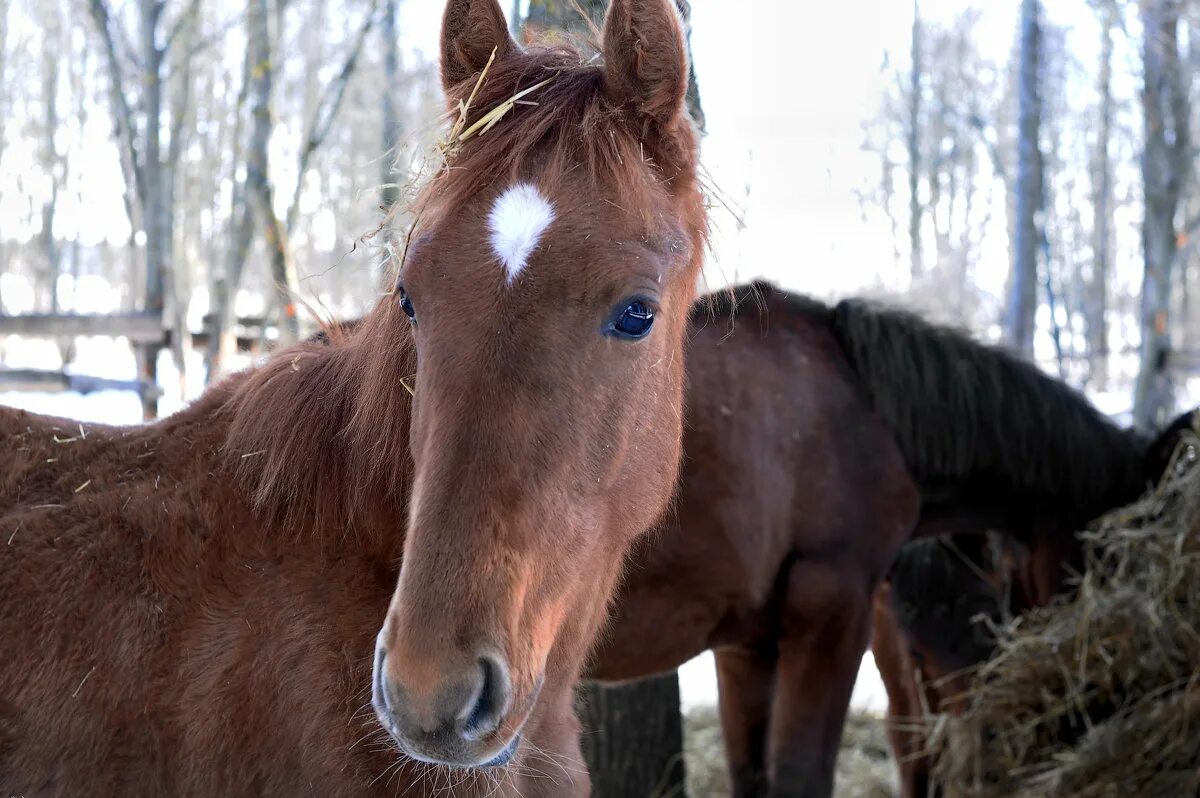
[373,0,706,767]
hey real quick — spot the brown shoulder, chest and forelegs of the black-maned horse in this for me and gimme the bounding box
[588,288,919,796]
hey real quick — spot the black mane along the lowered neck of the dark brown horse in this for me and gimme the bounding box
[830,300,1147,524]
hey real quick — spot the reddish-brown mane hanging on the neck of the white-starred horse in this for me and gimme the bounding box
[226,308,415,536]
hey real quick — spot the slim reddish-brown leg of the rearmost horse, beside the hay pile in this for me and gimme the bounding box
[871,582,929,798]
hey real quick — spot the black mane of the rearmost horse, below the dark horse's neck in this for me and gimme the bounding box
[888,536,1007,670]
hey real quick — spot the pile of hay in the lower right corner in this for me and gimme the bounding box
[932,420,1200,798]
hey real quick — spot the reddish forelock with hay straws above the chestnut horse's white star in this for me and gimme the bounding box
[408,48,708,265]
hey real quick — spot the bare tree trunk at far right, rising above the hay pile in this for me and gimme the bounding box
[1133,0,1194,427]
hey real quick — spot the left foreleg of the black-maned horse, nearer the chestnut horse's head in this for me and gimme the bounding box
[714,646,775,798]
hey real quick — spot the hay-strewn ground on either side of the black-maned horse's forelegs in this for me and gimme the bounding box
[684,707,896,798]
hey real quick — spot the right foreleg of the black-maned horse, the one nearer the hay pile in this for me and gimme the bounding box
[769,559,871,798]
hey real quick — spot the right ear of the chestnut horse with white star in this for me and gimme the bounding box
[604,0,688,124]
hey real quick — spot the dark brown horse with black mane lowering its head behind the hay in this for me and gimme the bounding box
[588,286,1146,796]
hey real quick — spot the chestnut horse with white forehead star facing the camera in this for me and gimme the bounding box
[0,0,706,796]
